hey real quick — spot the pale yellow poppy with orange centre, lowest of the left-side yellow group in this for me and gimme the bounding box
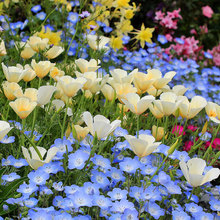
[9,98,37,119]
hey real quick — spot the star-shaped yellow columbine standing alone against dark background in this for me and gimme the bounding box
[134,24,154,48]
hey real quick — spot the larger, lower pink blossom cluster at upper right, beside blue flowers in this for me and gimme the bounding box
[164,36,201,59]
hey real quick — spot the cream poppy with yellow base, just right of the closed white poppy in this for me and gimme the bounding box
[58,76,86,97]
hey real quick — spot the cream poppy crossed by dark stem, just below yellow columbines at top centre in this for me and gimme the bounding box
[87,34,110,50]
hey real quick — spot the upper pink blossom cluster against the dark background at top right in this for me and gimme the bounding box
[155,8,182,29]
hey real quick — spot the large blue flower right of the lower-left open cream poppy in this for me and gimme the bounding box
[68,150,89,170]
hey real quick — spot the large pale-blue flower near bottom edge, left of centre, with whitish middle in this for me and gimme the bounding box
[69,190,92,208]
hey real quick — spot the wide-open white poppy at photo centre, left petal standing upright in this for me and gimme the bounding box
[82,112,121,139]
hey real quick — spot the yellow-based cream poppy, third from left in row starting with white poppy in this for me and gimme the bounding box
[31,60,55,79]
